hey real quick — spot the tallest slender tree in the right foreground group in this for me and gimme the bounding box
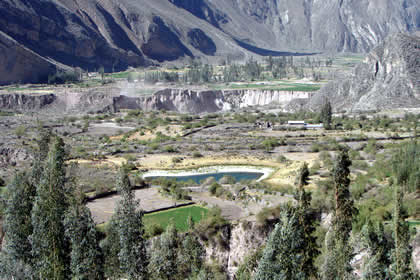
[322,150,357,280]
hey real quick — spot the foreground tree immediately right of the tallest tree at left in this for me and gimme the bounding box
[64,189,104,280]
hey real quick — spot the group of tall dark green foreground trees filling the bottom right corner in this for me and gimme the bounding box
[248,150,419,280]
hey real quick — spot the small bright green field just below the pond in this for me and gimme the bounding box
[143,205,208,231]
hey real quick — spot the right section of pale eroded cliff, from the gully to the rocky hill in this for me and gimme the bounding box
[113,89,312,114]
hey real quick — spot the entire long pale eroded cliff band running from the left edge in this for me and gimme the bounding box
[0,88,313,114]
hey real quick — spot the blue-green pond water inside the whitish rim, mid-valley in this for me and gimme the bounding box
[147,172,264,184]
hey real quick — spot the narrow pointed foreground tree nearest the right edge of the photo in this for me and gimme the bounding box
[391,186,419,280]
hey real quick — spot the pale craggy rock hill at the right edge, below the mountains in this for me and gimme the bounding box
[307,32,420,112]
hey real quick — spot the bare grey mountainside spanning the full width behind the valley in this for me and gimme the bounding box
[0,0,420,84]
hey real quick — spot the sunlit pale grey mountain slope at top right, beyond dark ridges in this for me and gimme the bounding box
[168,0,420,52]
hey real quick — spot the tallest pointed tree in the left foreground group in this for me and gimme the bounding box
[31,137,70,280]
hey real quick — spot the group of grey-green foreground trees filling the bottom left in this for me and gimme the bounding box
[0,131,208,279]
